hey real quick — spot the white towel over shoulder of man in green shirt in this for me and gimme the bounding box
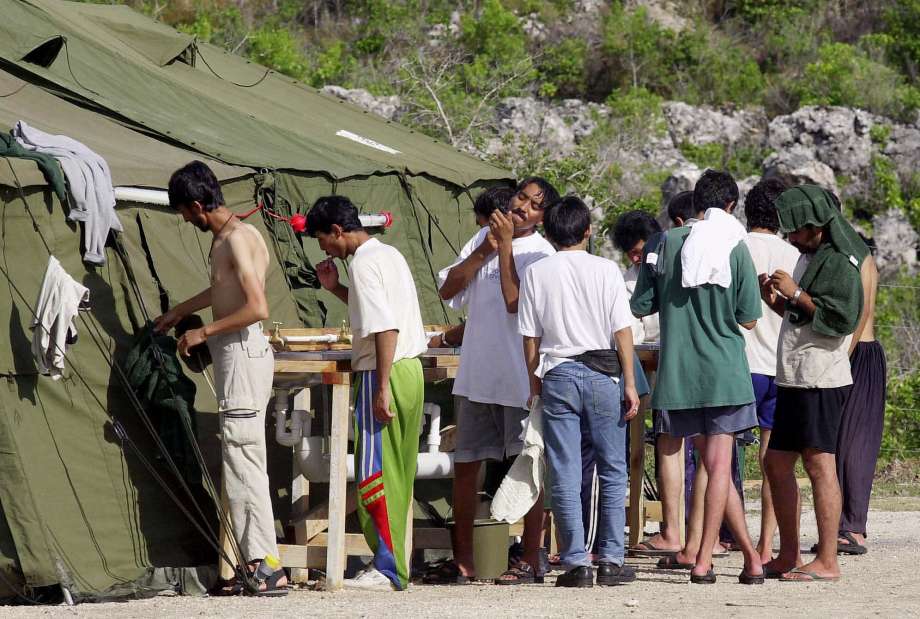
[680,208,747,288]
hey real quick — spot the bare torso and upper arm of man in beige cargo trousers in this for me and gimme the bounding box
[211,220,270,320]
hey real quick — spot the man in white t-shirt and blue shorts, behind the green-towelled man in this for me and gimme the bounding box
[741,178,799,563]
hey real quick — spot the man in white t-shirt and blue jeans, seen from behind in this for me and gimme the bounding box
[518,197,639,587]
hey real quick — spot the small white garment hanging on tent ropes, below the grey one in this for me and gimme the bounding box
[30,256,89,380]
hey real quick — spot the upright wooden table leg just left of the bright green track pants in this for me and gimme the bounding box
[326,373,351,591]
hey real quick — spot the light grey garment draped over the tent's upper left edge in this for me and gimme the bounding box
[12,120,122,264]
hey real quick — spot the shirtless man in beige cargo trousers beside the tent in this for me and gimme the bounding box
[155,161,287,595]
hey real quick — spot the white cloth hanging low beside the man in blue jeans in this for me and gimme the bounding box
[491,397,546,522]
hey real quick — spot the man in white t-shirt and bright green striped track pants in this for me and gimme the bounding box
[307,196,428,590]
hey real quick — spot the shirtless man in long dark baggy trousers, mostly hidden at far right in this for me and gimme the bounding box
[837,243,887,555]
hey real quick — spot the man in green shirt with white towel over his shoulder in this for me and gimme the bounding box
[630,170,763,584]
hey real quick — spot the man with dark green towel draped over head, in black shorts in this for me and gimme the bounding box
[761,185,869,582]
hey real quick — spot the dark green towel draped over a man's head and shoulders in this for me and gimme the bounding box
[776,185,869,337]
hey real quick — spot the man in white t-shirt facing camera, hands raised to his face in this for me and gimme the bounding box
[434,178,559,584]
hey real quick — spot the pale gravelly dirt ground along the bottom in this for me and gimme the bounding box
[7,506,920,619]
